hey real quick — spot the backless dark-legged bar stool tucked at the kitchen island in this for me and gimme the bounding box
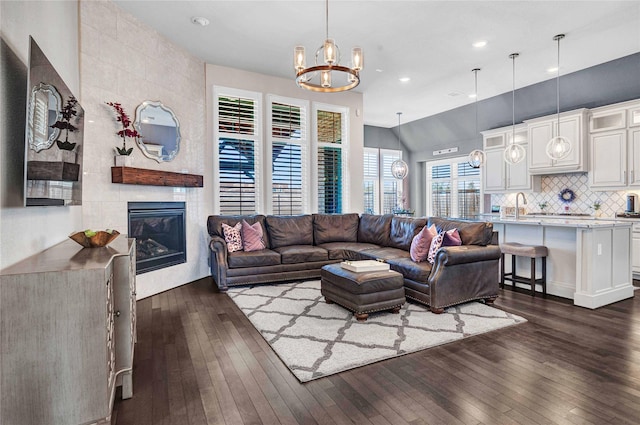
[500,242,548,297]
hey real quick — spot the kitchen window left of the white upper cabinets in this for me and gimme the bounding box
[427,158,482,219]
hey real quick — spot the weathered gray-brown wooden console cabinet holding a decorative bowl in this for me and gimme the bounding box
[0,236,136,425]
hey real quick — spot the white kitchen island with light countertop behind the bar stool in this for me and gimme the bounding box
[490,216,633,309]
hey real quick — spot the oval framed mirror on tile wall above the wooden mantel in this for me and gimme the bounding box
[133,100,180,162]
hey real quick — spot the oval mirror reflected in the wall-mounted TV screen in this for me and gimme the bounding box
[27,83,62,152]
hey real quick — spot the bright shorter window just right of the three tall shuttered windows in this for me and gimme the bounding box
[363,148,405,214]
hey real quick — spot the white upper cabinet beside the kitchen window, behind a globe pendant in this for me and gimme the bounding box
[482,124,540,193]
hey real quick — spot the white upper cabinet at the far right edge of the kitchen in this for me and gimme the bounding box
[589,100,640,190]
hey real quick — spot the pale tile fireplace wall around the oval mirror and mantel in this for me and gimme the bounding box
[79,1,210,298]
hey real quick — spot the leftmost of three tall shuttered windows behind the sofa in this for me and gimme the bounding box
[214,87,262,215]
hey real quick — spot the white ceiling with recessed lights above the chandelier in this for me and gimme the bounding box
[115,0,640,127]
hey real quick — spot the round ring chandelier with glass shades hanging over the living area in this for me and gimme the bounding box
[293,0,364,93]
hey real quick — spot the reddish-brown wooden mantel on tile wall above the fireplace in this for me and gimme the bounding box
[111,167,203,187]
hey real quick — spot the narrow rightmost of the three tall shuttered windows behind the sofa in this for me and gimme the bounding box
[314,105,348,214]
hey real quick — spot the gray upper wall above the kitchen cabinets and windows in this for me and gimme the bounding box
[364,53,640,214]
